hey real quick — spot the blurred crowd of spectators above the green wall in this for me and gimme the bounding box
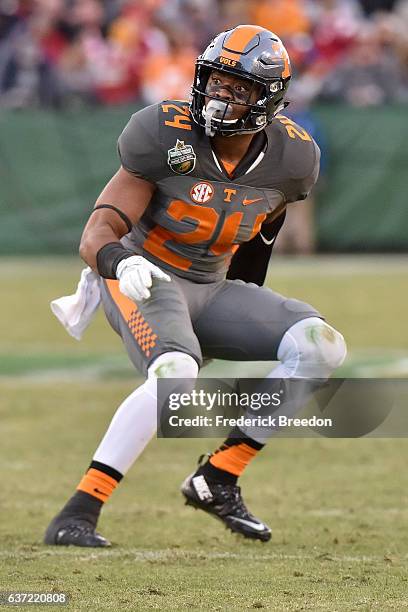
[0,0,408,107]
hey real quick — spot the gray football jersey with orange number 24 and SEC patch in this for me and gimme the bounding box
[118,100,320,283]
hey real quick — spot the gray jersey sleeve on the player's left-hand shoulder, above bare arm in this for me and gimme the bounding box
[118,104,166,183]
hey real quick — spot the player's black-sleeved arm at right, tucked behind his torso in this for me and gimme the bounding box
[227,141,320,287]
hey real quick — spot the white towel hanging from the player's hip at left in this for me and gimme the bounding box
[50,267,101,340]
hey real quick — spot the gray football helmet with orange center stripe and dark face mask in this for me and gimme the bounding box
[191,25,291,136]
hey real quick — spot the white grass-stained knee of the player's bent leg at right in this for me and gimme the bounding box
[278,317,347,378]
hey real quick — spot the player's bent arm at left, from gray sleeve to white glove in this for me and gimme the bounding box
[79,105,171,301]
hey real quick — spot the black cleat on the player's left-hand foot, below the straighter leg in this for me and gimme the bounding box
[44,515,111,548]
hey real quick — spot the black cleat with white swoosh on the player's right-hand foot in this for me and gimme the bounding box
[181,473,271,542]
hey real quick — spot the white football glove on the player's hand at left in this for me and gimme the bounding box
[116,255,171,302]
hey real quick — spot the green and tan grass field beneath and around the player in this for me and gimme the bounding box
[0,257,408,611]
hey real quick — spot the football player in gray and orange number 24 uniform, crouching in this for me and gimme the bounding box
[45,25,346,547]
